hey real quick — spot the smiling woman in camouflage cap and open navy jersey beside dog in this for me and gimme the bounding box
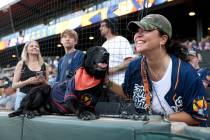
[108,14,208,126]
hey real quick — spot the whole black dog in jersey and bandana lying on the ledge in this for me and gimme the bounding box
[8,46,109,120]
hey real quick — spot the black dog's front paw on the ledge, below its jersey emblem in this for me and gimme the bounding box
[78,111,99,120]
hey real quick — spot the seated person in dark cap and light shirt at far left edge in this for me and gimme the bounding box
[0,77,16,110]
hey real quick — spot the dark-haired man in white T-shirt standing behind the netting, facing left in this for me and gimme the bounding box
[100,19,134,84]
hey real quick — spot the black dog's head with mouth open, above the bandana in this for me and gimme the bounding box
[83,46,109,79]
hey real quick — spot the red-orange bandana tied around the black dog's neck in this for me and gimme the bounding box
[75,67,101,90]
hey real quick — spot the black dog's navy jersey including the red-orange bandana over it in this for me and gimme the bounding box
[51,68,101,113]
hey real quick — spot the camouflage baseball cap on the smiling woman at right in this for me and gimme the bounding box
[128,14,172,39]
